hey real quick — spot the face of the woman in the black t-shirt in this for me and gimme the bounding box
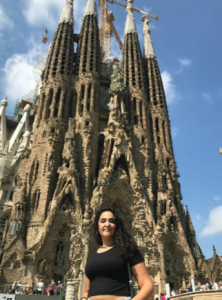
[98,211,116,240]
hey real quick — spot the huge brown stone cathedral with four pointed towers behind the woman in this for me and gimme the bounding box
[0,0,222,299]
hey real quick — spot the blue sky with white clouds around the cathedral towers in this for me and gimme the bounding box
[0,0,222,258]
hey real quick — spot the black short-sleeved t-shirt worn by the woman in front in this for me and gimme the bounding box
[85,246,144,297]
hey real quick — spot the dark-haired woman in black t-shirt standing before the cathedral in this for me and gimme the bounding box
[81,208,153,300]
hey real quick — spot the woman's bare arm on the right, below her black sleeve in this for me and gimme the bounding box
[131,262,153,300]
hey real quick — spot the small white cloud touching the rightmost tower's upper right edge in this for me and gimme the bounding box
[161,71,179,104]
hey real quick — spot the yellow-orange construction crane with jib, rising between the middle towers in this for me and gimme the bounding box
[99,0,159,58]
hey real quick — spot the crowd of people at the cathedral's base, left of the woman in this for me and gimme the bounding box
[6,279,62,296]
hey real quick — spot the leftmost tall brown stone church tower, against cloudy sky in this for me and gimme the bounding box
[2,0,75,282]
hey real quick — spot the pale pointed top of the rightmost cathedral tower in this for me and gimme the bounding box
[141,16,156,58]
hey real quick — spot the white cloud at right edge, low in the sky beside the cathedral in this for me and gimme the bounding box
[201,205,222,236]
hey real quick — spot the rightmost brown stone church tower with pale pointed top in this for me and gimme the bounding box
[142,16,203,290]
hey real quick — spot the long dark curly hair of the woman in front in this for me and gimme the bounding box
[94,207,137,259]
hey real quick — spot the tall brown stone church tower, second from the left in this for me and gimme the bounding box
[75,0,100,210]
